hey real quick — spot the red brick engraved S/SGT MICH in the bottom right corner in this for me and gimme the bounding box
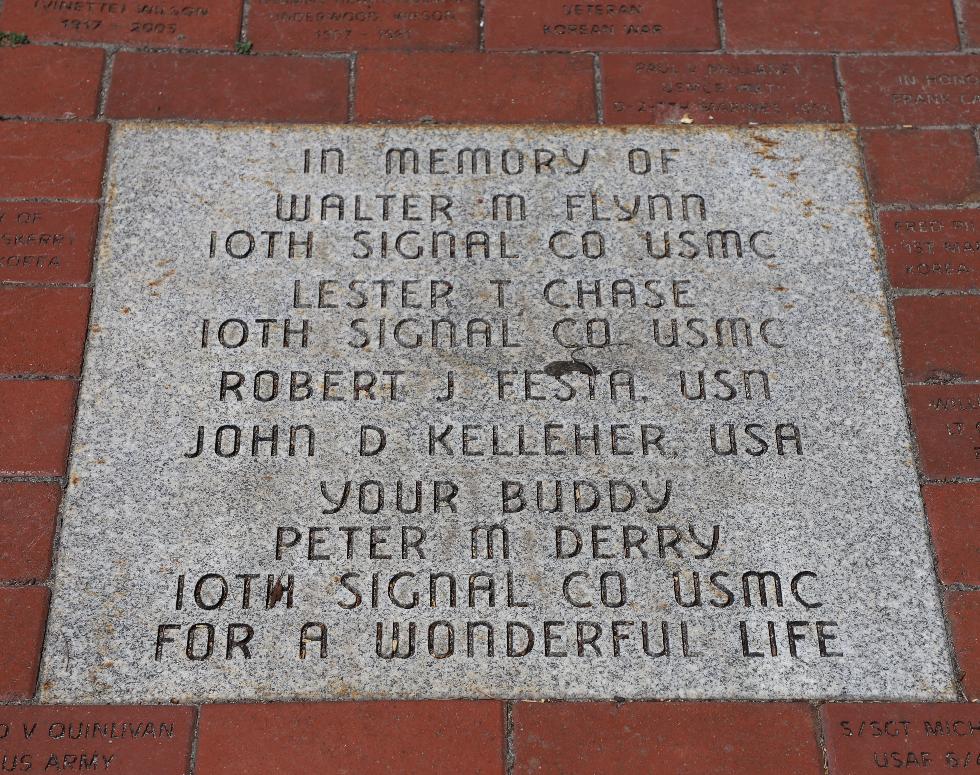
[820,702,980,775]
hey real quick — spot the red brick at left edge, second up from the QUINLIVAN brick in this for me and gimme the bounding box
[0,482,61,581]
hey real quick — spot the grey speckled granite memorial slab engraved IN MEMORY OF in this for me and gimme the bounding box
[41,123,955,702]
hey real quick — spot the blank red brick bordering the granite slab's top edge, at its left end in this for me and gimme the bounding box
[106,52,348,123]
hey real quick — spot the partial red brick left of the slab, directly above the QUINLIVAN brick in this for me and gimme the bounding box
[0,587,49,704]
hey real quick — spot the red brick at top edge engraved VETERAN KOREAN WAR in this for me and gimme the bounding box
[484,0,718,51]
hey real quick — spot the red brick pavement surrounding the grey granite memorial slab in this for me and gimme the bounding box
[0,0,980,775]
